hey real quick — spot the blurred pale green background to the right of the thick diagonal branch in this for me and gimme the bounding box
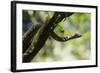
[32,13,91,62]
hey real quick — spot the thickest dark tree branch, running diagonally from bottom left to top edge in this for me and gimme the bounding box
[23,12,73,62]
